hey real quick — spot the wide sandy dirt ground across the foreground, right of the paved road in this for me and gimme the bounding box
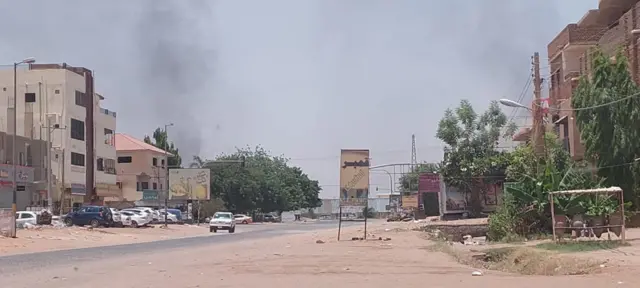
[2,223,640,288]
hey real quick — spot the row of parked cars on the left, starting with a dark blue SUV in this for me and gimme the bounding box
[61,206,182,228]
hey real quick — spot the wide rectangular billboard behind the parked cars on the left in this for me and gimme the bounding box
[169,168,211,200]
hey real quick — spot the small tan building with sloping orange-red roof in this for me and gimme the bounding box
[113,133,173,206]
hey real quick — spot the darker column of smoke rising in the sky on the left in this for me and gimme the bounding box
[134,0,213,161]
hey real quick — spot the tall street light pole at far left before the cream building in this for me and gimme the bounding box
[11,57,36,238]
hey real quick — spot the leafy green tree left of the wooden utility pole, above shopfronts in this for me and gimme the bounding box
[436,100,512,215]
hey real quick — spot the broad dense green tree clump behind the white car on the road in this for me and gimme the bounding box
[208,147,321,213]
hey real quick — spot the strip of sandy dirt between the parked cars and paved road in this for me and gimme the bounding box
[0,225,209,256]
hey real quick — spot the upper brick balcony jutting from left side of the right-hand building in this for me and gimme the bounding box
[547,23,607,59]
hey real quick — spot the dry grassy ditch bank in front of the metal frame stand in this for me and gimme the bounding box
[432,242,601,276]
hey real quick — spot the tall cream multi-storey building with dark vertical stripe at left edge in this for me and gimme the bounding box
[0,64,119,212]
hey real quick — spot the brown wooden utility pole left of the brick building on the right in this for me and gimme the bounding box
[532,52,545,155]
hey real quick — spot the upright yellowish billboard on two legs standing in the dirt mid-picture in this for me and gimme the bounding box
[340,149,369,206]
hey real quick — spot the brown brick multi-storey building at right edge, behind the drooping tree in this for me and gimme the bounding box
[547,0,639,160]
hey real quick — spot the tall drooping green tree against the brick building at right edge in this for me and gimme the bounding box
[571,49,640,206]
